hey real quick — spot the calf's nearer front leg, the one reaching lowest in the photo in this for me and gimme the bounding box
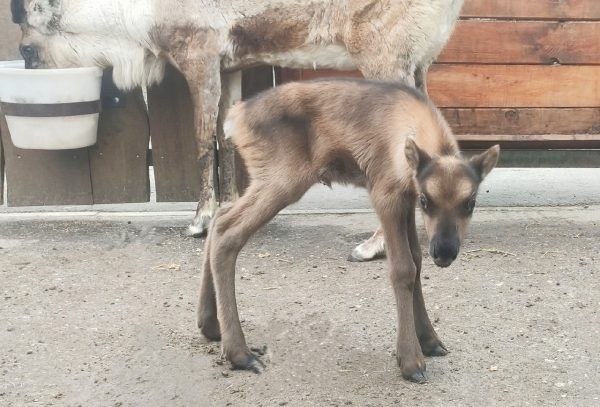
[373,199,426,383]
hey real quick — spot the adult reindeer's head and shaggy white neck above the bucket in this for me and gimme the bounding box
[18,0,165,89]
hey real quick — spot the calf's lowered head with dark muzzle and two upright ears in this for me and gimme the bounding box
[404,138,500,267]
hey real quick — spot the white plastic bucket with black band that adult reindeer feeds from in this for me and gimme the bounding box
[0,61,102,150]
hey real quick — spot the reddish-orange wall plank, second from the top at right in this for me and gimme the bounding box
[437,20,600,64]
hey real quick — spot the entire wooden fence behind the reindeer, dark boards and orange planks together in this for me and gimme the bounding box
[0,0,600,206]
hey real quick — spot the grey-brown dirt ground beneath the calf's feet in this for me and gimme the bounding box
[0,207,600,406]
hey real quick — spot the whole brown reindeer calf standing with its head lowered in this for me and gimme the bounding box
[198,79,499,382]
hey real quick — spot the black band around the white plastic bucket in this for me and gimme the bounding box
[0,100,101,117]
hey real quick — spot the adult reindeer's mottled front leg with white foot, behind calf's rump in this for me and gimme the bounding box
[180,55,221,236]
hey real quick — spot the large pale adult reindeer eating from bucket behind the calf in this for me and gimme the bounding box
[11,0,463,260]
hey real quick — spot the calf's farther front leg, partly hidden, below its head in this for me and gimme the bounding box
[408,210,448,356]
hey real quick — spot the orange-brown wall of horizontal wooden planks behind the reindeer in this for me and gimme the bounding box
[284,0,600,148]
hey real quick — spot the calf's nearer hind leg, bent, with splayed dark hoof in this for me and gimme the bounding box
[209,179,307,372]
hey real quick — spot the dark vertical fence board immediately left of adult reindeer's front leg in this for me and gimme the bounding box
[148,66,202,202]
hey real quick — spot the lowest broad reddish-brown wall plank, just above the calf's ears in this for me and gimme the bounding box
[442,108,600,134]
